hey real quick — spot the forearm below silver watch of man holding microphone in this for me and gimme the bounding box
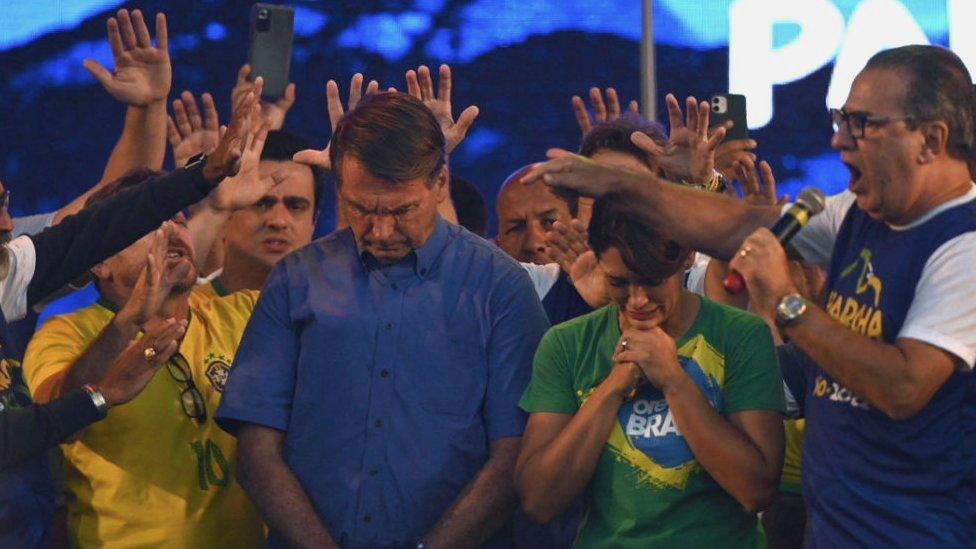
[784,305,941,418]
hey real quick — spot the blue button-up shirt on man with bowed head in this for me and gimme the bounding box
[217,219,548,547]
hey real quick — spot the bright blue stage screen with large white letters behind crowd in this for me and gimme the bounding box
[0,0,976,234]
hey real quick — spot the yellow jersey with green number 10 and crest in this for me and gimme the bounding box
[24,291,264,548]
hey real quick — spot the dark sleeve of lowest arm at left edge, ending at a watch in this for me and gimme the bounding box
[0,389,99,473]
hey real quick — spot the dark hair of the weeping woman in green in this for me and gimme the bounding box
[587,199,691,281]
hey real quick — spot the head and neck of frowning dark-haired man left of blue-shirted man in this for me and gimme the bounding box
[190,131,316,302]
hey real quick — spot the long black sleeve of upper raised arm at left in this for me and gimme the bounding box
[27,164,213,307]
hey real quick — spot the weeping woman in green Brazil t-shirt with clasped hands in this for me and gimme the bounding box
[515,201,784,548]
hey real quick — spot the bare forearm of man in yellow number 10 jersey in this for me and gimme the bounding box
[58,316,139,398]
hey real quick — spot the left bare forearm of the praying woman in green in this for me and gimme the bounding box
[515,382,623,522]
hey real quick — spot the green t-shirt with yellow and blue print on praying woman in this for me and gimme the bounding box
[519,298,785,549]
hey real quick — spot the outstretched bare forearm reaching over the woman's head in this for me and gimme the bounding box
[616,173,779,259]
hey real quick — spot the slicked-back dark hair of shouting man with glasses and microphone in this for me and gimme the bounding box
[861,45,976,158]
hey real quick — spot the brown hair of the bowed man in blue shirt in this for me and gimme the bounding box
[329,92,445,185]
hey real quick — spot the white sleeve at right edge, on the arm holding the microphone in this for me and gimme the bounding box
[898,232,976,369]
